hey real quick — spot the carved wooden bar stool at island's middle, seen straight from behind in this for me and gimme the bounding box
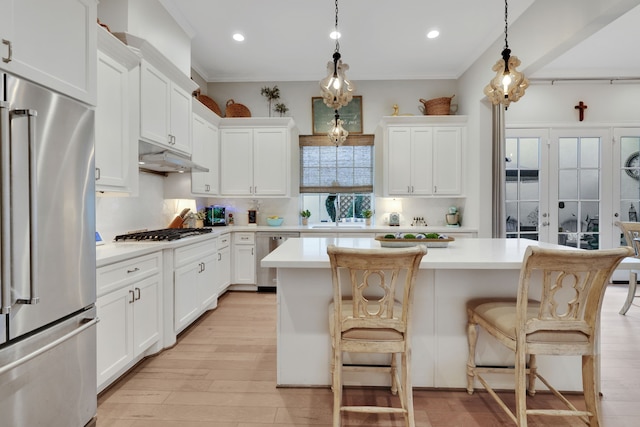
[327,245,427,427]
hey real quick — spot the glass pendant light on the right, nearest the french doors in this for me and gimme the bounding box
[484,0,529,110]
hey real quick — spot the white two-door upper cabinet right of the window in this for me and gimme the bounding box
[378,116,466,197]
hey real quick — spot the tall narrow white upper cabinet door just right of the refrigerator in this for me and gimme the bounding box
[95,26,139,193]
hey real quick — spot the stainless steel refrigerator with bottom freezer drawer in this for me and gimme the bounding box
[0,73,97,427]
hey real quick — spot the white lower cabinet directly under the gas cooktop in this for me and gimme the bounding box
[173,239,218,333]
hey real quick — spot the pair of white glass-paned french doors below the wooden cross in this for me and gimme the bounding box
[505,129,608,249]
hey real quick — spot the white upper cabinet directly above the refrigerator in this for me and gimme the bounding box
[0,0,98,105]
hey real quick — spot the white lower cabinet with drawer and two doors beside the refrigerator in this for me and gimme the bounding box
[96,252,162,391]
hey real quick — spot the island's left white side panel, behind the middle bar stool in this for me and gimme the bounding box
[277,268,435,387]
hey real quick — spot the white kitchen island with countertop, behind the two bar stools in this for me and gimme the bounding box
[262,238,637,390]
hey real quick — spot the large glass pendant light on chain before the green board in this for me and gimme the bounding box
[320,0,355,110]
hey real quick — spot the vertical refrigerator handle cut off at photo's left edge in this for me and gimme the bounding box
[0,101,11,314]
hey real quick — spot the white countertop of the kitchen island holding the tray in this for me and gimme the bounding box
[261,237,639,270]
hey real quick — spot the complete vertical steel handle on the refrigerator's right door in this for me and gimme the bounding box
[11,109,40,304]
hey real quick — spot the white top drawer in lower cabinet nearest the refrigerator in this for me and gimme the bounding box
[96,252,162,296]
